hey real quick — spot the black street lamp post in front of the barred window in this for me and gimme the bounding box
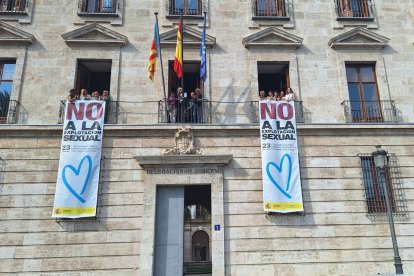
[372,146,404,274]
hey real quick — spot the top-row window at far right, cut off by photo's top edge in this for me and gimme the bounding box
[335,0,372,19]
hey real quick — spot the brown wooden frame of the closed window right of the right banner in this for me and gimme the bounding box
[345,62,384,122]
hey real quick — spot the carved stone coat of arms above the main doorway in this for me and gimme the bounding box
[162,128,201,155]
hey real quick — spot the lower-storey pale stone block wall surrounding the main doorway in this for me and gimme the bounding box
[0,125,414,275]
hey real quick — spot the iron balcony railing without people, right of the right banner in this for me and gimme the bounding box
[342,101,398,123]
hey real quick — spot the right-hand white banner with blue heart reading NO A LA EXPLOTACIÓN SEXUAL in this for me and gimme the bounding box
[259,101,303,213]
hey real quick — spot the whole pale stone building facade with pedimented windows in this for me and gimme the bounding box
[0,0,414,275]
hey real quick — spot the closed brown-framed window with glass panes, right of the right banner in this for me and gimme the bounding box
[346,64,383,122]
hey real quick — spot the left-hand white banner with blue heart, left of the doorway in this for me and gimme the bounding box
[52,101,105,218]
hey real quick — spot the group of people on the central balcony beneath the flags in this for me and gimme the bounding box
[167,87,203,123]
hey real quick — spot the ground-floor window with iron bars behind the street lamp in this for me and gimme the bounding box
[359,154,397,213]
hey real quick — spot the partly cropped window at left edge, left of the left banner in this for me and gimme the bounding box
[0,60,16,123]
